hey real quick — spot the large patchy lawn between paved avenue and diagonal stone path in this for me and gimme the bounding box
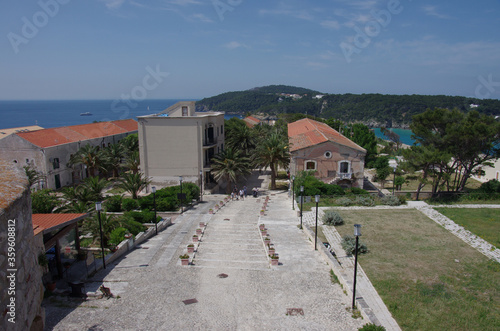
[336,210,500,330]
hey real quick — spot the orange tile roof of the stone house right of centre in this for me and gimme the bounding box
[288,118,366,153]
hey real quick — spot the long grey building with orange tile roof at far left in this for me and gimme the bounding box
[0,119,137,189]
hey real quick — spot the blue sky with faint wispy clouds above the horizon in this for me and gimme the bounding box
[0,0,500,100]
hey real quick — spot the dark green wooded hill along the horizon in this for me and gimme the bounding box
[197,85,500,127]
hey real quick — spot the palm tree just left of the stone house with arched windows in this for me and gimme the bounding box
[253,131,290,190]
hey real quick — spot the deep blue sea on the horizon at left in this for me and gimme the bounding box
[0,99,242,129]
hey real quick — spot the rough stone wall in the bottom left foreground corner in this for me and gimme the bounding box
[0,161,44,330]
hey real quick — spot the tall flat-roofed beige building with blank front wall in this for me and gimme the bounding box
[138,101,224,189]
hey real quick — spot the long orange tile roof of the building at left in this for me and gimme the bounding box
[16,119,138,148]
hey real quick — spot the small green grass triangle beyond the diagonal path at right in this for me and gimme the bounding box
[436,208,500,248]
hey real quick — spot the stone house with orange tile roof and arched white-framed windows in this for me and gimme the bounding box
[288,118,366,188]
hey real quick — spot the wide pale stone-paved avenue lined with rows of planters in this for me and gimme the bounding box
[45,175,368,330]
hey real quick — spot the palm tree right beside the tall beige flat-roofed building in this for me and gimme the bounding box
[211,147,251,194]
